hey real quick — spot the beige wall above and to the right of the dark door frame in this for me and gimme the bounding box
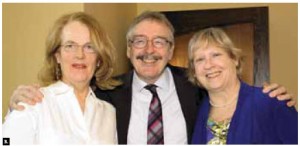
[137,3,298,97]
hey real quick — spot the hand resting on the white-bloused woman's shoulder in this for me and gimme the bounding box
[9,84,44,111]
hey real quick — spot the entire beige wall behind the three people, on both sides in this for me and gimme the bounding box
[2,3,298,120]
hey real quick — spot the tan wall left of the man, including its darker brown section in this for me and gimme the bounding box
[2,3,137,121]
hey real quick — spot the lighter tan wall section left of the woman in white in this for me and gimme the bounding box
[2,3,83,120]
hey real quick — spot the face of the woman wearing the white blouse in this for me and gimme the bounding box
[55,21,97,85]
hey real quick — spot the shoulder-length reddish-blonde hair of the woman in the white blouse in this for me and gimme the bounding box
[38,12,120,89]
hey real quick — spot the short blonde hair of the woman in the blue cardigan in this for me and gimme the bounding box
[188,28,242,87]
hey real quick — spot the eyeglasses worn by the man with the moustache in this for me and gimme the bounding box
[129,36,171,49]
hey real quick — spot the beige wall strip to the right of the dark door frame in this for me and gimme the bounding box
[269,4,298,101]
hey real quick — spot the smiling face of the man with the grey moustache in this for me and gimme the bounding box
[127,20,173,83]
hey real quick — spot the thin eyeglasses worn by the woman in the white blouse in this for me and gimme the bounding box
[60,43,96,53]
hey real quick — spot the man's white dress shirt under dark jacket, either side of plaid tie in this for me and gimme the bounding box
[127,68,187,144]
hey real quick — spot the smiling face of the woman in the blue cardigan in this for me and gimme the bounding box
[193,45,238,91]
